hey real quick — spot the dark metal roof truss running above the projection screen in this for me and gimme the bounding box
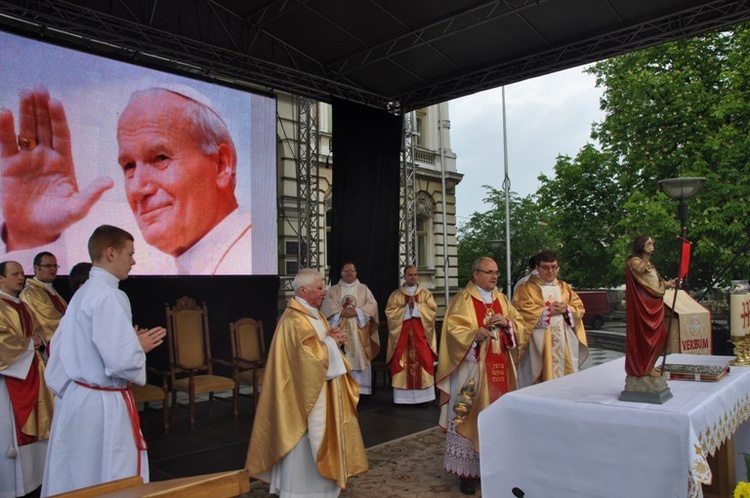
[0,0,390,108]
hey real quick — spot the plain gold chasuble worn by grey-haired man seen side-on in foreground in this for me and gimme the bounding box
[245,299,368,488]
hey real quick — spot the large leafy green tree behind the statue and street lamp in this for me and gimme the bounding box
[539,24,750,288]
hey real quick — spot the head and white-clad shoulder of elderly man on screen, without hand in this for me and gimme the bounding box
[117,87,252,275]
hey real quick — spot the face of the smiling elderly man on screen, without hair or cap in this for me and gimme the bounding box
[117,92,226,256]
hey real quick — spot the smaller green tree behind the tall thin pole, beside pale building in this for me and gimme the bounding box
[457,185,553,289]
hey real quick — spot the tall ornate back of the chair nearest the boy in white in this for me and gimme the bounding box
[166,296,212,374]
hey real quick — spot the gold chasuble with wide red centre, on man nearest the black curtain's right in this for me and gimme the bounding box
[385,285,437,390]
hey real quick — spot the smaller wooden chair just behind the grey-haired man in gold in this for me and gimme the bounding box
[229,318,266,407]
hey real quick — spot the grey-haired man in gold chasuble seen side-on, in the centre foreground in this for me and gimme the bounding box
[246,269,368,498]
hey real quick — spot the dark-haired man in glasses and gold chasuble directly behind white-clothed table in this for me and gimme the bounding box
[513,250,588,387]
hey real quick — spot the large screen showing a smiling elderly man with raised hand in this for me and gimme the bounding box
[0,32,277,275]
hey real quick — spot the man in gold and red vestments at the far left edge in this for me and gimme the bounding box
[0,261,53,496]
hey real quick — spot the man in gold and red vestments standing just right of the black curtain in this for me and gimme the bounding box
[385,265,437,405]
